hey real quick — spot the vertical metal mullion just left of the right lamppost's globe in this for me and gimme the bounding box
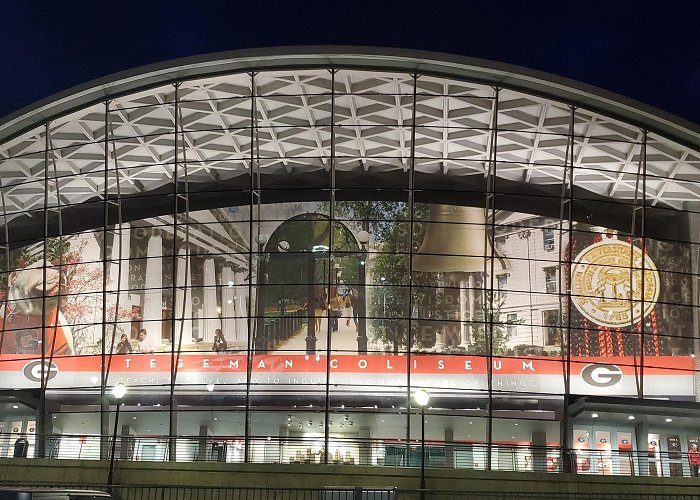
[404,73,416,458]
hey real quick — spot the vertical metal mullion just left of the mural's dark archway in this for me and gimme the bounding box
[243,72,259,463]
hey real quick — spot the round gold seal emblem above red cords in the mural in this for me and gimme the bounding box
[571,239,660,328]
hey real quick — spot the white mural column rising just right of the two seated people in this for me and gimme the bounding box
[141,233,163,346]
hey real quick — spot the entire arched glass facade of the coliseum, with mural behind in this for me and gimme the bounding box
[0,59,700,475]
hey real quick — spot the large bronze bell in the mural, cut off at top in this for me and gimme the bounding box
[413,205,492,273]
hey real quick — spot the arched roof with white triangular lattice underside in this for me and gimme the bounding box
[0,47,700,241]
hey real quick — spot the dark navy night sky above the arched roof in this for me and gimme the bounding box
[0,0,700,124]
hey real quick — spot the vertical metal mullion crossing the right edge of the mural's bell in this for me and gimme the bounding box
[482,87,500,470]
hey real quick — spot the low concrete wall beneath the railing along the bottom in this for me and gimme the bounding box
[0,459,700,500]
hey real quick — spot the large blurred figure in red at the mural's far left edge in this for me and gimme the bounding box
[0,261,75,356]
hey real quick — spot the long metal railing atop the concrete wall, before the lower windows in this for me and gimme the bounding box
[0,434,694,477]
